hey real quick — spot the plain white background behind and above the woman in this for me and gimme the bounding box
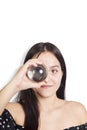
[0,0,87,108]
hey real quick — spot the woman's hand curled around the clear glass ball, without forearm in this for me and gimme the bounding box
[11,59,42,90]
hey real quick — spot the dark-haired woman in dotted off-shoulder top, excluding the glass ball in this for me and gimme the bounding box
[0,42,87,130]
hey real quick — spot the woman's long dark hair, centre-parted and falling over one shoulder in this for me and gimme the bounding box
[18,42,66,130]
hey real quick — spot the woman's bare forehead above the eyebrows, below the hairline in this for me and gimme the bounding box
[38,51,60,66]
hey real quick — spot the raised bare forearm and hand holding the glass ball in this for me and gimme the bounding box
[0,59,42,115]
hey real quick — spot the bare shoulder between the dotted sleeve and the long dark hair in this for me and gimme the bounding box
[6,102,25,125]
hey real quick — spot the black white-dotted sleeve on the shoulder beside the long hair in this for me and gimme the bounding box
[0,109,16,130]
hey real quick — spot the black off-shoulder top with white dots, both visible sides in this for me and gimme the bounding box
[0,109,87,130]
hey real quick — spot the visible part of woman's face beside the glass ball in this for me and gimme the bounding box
[35,51,63,97]
